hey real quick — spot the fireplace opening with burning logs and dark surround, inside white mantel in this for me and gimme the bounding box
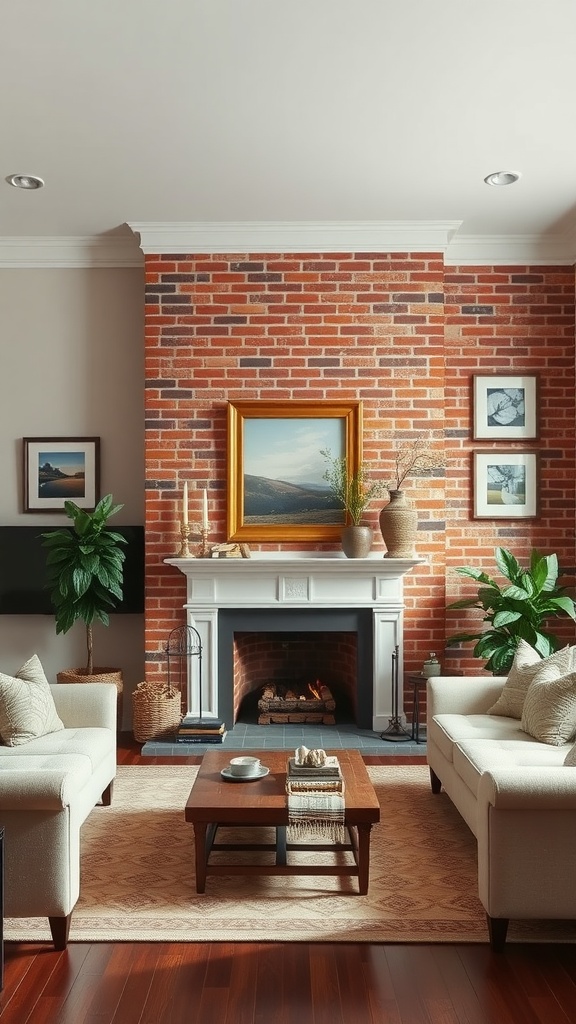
[218,608,372,728]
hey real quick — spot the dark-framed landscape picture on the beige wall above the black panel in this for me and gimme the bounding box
[23,437,100,512]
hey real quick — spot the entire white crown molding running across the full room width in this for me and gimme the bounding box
[0,220,576,268]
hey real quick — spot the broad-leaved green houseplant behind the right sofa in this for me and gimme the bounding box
[447,548,576,675]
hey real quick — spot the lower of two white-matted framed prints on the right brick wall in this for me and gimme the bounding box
[472,450,539,519]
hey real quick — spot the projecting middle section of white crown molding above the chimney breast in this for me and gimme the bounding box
[128,220,461,254]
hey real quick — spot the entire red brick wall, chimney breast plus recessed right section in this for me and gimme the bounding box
[141,253,576,700]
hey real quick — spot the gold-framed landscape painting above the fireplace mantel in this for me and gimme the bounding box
[228,401,362,542]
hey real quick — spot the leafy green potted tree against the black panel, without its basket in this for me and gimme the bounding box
[42,495,126,676]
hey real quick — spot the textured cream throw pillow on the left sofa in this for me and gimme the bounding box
[0,654,64,746]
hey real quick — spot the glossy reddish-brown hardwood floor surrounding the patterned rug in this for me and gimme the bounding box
[0,737,576,1024]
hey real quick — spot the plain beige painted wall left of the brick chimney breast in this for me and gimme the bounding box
[0,268,143,728]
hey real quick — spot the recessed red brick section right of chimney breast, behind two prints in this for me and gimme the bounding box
[444,266,576,672]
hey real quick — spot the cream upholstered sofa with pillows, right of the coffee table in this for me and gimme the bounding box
[426,645,576,950]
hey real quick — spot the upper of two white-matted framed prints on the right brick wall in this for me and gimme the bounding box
[471,374,538,441]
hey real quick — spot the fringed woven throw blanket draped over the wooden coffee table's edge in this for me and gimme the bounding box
[286,776,345,844]
